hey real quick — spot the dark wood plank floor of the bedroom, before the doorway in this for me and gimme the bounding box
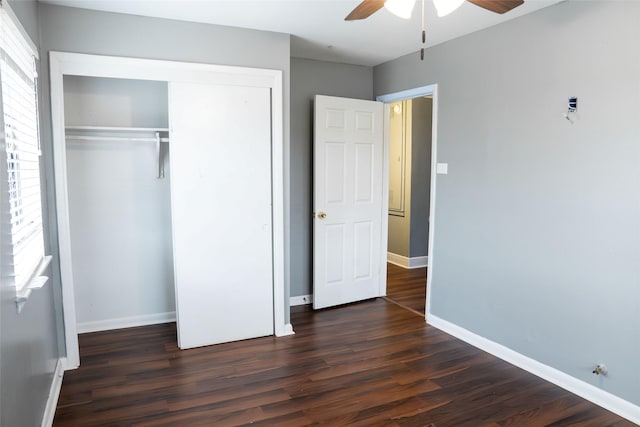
[55,298,633,427]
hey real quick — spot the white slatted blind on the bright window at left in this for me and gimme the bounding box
[0,3,44,292]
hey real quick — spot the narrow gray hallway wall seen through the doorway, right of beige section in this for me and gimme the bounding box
[409,98,433,258]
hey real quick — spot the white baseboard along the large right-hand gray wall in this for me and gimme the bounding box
[427,314,640,425]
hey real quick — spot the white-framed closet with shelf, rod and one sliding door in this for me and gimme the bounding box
[49,52,286,369]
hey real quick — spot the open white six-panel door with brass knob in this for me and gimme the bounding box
[313,95,384,309]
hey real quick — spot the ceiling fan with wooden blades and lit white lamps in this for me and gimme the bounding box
[344,0,524,21]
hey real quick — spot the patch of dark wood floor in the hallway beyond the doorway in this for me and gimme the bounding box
[387,263,427,315]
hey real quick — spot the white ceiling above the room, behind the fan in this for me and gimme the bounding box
[40,0,561,66]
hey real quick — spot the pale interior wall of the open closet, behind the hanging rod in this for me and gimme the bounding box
[64,76,175,333]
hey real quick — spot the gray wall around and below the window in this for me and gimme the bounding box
[0,2,58,427]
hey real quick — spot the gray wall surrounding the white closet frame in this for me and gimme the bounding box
[40,4,290,335]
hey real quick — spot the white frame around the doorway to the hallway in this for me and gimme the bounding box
[376,84,438,323]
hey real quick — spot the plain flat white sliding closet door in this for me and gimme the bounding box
[169,83,274,349]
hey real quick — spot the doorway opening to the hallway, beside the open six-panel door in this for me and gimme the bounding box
[377,85,437,316]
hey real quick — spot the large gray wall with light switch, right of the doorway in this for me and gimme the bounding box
[374,1,640,405]
